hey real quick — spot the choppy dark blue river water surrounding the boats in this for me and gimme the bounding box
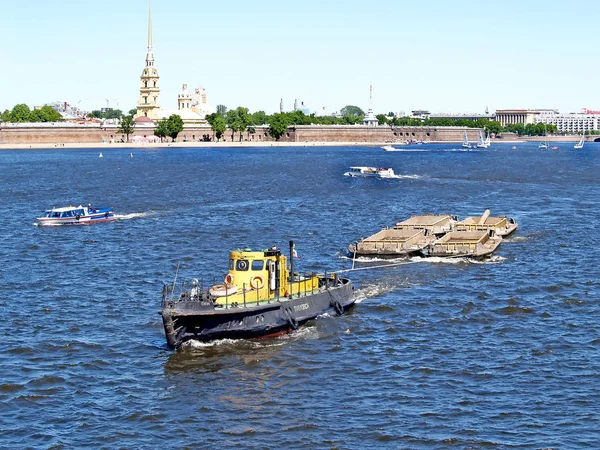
[0,144,600,449]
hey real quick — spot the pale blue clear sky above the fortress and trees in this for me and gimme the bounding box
[0,0,600,113]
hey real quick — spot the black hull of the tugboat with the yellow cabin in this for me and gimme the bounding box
[160,279,356,348]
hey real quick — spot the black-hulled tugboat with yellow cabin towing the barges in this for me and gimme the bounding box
[159,241,356,349]
